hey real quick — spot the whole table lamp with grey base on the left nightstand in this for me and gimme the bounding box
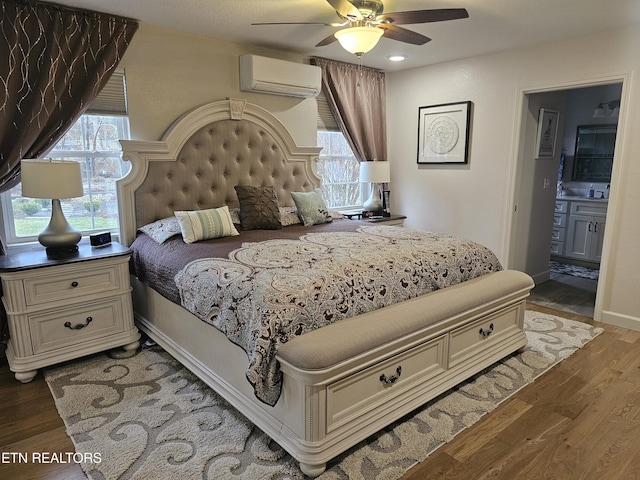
[20,159,84,257]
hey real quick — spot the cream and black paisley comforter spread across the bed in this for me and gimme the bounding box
[175,225,502,405]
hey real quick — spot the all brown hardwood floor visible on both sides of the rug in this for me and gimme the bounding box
[0,305,640,480]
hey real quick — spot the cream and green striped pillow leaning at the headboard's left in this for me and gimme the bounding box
[173,205,240,243]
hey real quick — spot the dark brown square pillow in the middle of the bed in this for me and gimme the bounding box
[235,185,282,230]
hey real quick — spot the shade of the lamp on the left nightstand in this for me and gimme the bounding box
[20,159,84,199]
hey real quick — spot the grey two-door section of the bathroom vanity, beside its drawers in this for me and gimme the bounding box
[564,201,607,263]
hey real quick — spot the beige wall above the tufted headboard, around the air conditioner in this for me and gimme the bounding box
[120,24,317,146]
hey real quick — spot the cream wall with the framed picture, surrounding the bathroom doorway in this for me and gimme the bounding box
[387,26,640,329]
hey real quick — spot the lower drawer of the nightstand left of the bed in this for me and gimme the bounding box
[29,297,124,354]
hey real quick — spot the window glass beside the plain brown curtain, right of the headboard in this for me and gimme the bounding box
[317,131,362,208]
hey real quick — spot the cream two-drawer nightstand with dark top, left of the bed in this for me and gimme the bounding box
[0,242,140,383]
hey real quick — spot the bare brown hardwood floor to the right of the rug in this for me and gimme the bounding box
[403,305,640,480]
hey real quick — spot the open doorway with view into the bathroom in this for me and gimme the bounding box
[510,80,622,318]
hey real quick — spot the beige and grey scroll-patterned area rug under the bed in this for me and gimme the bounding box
[45,311,602,480]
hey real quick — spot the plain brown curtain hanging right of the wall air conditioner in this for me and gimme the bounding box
[311,58,387,162]
